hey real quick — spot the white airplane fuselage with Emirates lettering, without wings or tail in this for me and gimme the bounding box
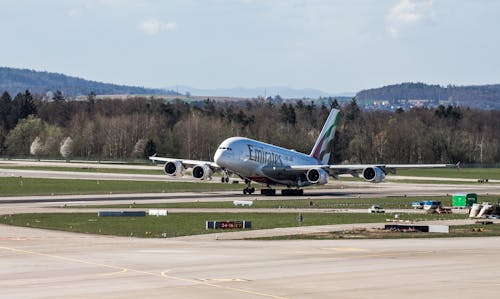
[214,137,318,186]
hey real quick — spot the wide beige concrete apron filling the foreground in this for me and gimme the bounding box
[0,226,500,298]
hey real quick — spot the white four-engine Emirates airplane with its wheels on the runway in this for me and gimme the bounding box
[149,109,459,196]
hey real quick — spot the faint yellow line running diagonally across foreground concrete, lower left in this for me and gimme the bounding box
[0,246,288,299]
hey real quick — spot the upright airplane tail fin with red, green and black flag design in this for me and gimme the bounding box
[309,109,340,165]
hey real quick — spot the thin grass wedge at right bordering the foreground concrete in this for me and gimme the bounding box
[258,224,500,240]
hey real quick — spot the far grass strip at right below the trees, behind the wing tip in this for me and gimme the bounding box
[394,168,500,180]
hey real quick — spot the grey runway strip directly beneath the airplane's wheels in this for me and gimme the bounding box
[0,182,500,215]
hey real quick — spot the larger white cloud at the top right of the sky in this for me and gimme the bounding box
[387,0,434,38]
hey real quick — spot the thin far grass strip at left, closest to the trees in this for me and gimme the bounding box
[0,164,164,175]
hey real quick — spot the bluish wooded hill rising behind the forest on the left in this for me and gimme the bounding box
[0,67,177,96]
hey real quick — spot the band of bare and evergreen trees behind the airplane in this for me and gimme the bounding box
[0,90,500,164]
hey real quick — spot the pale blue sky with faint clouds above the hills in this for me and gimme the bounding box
[0,0,500,94]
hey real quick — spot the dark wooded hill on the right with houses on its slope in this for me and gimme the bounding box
[356,83,500,109]
